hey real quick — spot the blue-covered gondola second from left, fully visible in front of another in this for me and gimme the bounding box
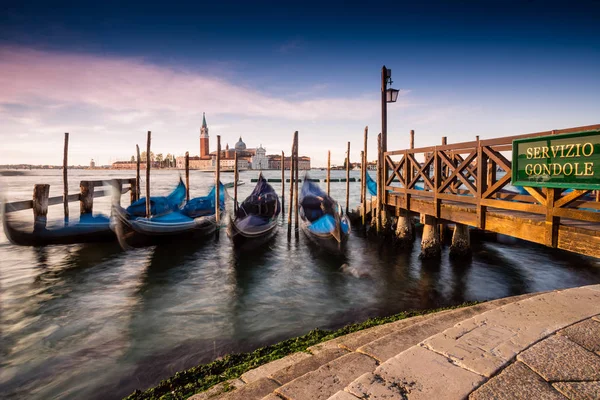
[113,183,225,249]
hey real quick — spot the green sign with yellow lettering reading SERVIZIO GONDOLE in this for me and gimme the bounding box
[512,130,600,190]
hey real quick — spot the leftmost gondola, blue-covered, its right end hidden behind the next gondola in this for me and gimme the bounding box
[2,180,185,246]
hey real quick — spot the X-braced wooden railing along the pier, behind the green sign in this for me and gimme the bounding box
[381,125,600,255]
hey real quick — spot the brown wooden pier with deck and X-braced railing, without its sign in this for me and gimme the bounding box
[360,125,600,258]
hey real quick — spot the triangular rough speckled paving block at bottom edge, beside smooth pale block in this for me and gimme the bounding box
[469,361,565,400]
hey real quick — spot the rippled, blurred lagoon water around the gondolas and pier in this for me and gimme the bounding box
[0,167,600,399]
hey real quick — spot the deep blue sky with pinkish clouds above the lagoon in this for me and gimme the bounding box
[0,0,600,167]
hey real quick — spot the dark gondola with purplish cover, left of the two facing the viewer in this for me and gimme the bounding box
[227,174,281,248]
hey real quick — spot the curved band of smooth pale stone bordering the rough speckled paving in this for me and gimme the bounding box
[338,285,600,400]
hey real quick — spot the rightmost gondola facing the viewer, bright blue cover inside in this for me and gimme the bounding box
[299,179,350,254]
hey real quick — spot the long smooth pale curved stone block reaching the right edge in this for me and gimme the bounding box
[423,288,600,377]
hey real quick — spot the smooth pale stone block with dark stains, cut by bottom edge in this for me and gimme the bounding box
[346,346,485,400]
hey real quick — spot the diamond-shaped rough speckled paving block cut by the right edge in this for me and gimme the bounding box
[517,335,600,382]
